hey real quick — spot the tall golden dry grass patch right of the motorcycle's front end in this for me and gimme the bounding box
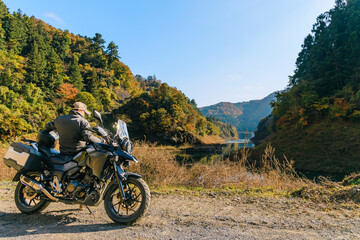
[130,142,305,190]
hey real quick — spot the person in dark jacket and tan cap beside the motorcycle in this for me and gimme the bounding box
[45,102,102,155]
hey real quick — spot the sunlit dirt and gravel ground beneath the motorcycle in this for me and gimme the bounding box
[0,182,360,240]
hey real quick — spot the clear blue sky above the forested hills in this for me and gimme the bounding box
[3,0,335,106]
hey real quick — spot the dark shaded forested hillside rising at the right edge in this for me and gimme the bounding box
[255,0,360,172]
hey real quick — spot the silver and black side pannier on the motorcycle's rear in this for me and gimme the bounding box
[4,143,43,171]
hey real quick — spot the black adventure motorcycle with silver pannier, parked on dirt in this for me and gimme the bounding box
[4,111,151,224]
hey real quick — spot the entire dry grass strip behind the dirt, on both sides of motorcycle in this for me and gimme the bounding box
[0,142,360,203]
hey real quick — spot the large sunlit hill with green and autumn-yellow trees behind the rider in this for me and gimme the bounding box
[0,1,229,143]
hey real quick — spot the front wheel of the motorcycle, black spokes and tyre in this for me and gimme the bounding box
[104,177,151,224]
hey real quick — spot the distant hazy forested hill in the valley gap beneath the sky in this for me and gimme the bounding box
[200,93,275,131]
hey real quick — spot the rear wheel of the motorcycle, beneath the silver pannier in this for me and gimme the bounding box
[14,176,50,214]
